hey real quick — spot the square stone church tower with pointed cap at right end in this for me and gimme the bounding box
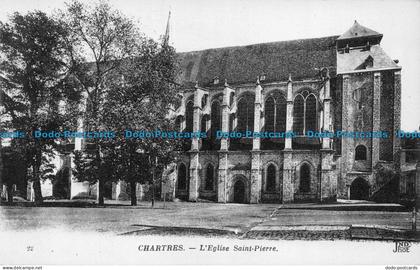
[335,21,401,199]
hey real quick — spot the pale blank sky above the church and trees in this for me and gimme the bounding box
[0,0,420,130]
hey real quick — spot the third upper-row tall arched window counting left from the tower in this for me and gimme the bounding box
[237,94,254,132]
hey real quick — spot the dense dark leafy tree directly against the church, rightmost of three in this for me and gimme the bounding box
[75,39,179,205]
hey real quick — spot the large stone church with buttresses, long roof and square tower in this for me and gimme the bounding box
[162,21,401,203]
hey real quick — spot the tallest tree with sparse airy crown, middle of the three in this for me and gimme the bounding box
[62,1,141,205]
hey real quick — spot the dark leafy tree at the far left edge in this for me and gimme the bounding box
[0,11,80,203]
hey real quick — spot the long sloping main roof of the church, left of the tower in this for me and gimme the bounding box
[178,36,338,86]
